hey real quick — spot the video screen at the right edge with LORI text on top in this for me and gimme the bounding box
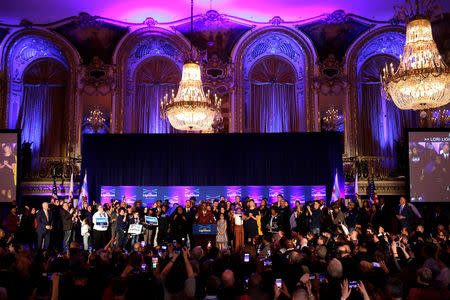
[408,131,450,202]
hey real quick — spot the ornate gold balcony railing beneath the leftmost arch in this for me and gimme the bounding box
[22,157,81,181]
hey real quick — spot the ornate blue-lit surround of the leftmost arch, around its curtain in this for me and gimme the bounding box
[2,29,81,156]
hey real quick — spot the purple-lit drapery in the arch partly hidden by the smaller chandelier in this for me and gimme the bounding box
[128,57,181,133]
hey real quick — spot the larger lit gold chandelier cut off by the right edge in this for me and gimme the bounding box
[380,1,450,110]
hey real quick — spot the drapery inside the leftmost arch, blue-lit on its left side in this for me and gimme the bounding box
[16,60,67,157]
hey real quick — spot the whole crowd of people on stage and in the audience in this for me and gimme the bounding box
[0,195,450,300]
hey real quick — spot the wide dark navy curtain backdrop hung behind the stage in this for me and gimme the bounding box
[81,132,344,202]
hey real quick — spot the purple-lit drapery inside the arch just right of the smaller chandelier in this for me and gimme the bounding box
[246,56,305,132]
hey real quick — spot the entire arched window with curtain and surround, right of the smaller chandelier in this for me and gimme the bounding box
[236,28,312,132]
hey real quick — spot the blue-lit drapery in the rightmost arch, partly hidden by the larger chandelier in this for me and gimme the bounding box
[358,55,419,168]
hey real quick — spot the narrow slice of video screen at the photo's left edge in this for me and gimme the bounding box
[0,132,18,202]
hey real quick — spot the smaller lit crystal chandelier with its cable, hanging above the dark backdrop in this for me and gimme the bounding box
[161,0,222,131]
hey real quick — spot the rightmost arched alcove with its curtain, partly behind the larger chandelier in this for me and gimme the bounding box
[349,31,419,171]
